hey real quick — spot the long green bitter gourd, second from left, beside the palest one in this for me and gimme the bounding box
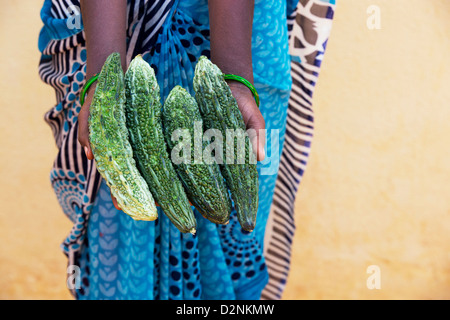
[125,55,197,234]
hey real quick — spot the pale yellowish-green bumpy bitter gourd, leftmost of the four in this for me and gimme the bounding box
[89,53,158,221]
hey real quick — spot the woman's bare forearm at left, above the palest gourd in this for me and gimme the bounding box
[81,0,127,79]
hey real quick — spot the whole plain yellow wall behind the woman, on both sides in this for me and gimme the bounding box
[0,0,450,299]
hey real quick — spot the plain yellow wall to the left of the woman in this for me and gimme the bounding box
[0,0,71,299]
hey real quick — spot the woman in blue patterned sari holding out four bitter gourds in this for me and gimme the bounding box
[39,0,336,299]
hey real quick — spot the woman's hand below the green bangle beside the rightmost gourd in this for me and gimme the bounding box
[227,80,266,161]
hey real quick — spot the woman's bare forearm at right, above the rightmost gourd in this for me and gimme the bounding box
[208,0,255,83]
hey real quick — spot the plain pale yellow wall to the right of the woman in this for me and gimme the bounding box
[284,0,450,299]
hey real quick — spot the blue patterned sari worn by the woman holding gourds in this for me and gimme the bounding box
[39,0,336,300]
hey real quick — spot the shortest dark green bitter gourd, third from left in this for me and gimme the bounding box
[162,86,231,224]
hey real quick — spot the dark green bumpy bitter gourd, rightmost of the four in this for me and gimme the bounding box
[193,56,258,232]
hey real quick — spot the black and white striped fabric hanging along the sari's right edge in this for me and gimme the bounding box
[261,0,335,300]
